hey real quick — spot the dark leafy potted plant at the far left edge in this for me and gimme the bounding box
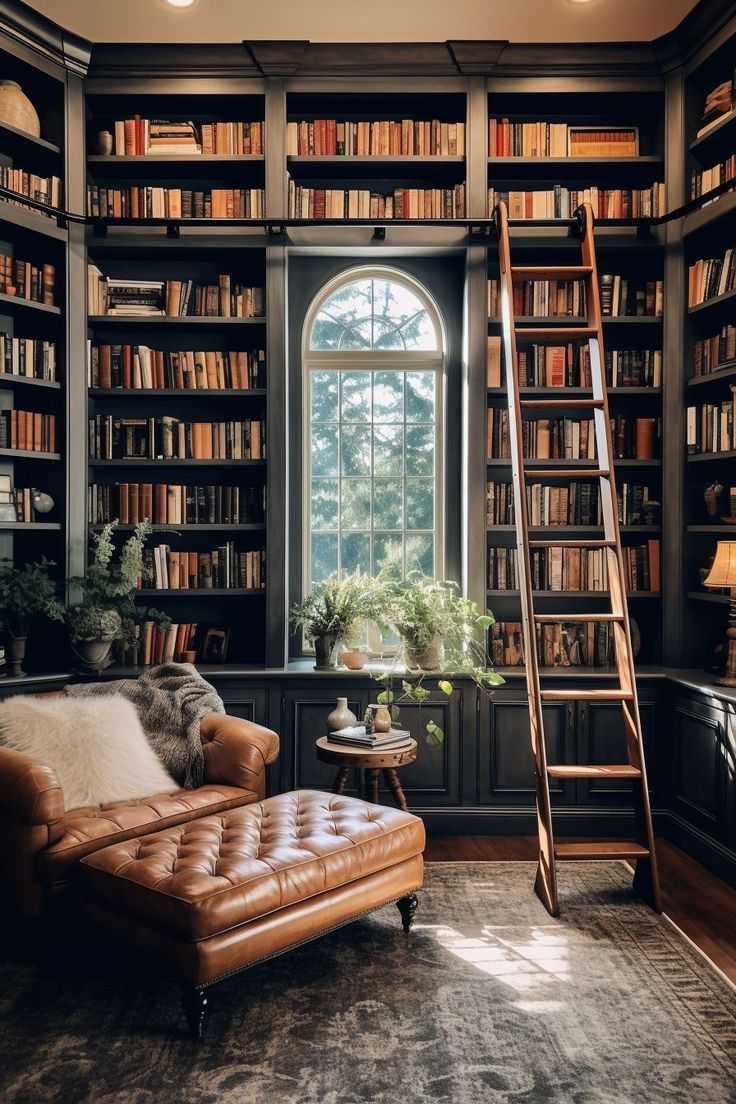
[0,559,64,678]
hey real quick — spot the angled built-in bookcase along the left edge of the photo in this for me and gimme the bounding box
[0,34,68,669]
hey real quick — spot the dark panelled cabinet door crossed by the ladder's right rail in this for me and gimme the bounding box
[576,692,657,806]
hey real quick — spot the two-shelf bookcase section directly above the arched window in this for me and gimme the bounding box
[286,88,468,219]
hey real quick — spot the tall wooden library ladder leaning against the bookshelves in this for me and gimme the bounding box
[493,203,661,916]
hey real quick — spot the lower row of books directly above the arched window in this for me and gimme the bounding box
[289,180,466,221]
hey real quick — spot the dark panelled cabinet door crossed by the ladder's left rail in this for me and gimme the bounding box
[479,690,575,805]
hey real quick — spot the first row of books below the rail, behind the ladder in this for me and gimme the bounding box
[488,273,664,318]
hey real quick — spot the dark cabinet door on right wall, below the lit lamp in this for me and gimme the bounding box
[670,698,734,843]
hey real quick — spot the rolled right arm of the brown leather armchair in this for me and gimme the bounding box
[200,713,279,796]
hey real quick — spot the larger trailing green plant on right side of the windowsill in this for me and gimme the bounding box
[375,575,504,744]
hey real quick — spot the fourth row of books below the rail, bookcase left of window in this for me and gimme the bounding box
[87,482,266,526]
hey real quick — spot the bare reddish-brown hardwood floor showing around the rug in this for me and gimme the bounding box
[425,836,736,984]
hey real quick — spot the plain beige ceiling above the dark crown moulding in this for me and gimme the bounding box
[24,0,696,42]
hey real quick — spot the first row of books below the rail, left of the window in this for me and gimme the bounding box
[87,265,264,318]
